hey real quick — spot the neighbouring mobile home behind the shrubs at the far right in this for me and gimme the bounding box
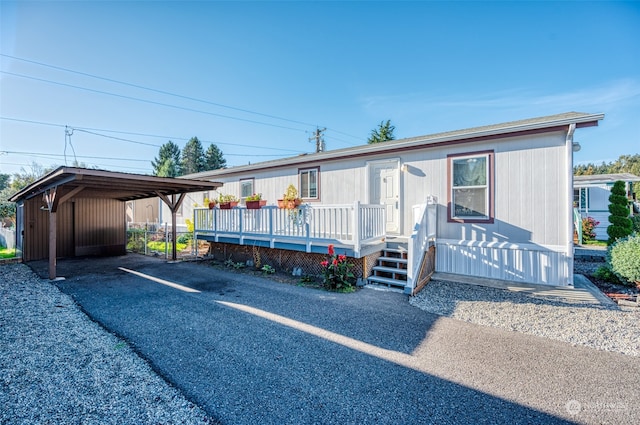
[573,173,640,241]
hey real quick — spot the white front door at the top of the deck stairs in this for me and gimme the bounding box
[369,161,400,233]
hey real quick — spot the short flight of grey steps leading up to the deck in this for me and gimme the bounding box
[367,243,409,288]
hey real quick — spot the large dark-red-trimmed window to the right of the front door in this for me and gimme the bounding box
[448,152,493,222]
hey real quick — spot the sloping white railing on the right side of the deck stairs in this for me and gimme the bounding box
[407,196,438,289]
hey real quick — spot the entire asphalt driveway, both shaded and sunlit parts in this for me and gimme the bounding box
[35,256,640,424]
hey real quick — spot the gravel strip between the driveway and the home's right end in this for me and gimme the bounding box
[410,261,640,356]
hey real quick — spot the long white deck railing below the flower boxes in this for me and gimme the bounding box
[194,202,385,254]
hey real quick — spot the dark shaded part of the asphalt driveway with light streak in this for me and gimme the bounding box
[25,255,571,424]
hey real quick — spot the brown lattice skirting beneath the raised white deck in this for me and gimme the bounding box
[209,242,382,279]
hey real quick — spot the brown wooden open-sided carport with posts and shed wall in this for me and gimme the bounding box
[10,167,222,279]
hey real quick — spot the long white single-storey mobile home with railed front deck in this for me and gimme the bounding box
[162,112,604,293]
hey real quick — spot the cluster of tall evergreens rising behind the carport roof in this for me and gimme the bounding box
[151,137,227,177]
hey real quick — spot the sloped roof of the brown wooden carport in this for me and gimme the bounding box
[9,167,222,202]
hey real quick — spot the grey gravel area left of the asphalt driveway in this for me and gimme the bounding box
[0,264,214,424]
